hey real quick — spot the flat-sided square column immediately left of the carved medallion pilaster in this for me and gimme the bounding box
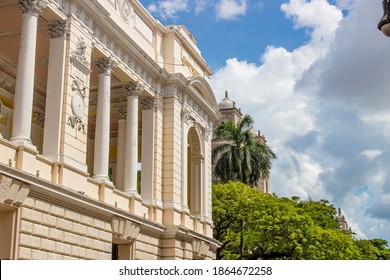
[42,21,67,161]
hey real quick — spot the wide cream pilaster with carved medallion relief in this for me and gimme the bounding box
[60,17,92,172]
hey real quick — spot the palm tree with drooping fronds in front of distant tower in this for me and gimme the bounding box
[212,115,276,187]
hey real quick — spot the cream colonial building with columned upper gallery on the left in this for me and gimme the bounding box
[0,0,220,260]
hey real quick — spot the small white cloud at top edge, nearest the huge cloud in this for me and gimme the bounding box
[215,0,248,20]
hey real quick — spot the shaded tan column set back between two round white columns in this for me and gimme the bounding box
[115,107,126,190]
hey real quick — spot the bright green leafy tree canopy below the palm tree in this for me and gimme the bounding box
[213,182,390,260]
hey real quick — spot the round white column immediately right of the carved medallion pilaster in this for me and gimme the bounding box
[93,58,116,182]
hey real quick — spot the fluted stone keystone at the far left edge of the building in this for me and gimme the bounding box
[0,174,30,207]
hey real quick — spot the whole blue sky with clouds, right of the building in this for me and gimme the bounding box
[140,0,390,243]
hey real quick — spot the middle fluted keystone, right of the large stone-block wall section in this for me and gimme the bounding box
[111,216,141,242]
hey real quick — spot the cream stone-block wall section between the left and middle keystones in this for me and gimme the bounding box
[19,197,112,260]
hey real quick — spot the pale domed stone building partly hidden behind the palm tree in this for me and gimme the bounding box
[213,91,270,193]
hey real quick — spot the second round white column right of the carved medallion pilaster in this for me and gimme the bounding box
[124,82,144,195]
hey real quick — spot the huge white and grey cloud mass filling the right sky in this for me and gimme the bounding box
[212,0,390,241]
